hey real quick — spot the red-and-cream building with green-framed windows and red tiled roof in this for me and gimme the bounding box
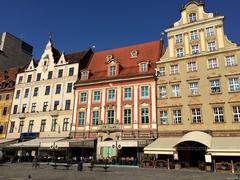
[72,41,162,159]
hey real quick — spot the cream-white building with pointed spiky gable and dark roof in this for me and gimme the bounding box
[7,40,92,140]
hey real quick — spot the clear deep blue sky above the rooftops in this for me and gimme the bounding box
[0,0,240,58]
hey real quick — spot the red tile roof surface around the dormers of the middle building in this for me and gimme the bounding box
[78,41,162,83]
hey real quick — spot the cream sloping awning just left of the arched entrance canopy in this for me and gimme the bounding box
[144,137,180,155]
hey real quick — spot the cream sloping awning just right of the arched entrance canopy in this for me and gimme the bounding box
[207,137,240,156]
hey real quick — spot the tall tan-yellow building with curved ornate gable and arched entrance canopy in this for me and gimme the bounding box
[145,0,240,165]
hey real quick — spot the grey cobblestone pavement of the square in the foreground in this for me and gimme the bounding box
[0,164,236,180]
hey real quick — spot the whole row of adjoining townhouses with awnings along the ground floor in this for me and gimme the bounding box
[0,0,240,169]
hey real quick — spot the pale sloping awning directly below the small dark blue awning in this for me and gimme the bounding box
[8,138,63,148]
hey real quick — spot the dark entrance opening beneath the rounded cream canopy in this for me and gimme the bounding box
[177,141,206,167]
